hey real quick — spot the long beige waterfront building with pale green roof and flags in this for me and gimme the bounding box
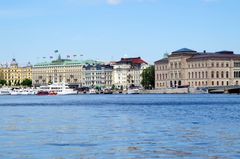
[33,55,99,87]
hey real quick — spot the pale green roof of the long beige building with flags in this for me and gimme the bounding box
[33,59,103,67]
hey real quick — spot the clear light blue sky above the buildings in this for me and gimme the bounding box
[0,0,240,65]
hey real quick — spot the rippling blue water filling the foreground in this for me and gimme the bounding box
[0,95,240,159]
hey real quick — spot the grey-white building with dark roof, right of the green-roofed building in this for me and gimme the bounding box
[84,64,113,88]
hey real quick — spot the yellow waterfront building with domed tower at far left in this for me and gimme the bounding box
[0,58,32,86]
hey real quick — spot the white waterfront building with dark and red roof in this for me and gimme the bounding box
[112,57,148,88]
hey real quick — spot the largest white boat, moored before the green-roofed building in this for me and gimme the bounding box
[38,83,78,95]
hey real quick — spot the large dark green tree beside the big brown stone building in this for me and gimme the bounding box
[141,66,155,89]
